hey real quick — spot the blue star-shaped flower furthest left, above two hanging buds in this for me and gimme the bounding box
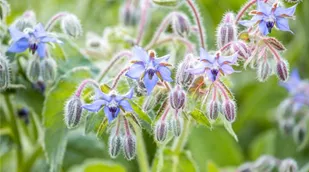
[8,23,60,58]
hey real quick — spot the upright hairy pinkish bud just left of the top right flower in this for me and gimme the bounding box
[217,12,237,48]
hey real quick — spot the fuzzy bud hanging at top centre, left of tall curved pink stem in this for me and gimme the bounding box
[172,13,191,37]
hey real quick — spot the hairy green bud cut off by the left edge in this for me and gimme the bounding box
[0,54,11,90]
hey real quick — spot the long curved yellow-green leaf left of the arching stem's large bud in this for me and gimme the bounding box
[43,68,91,171]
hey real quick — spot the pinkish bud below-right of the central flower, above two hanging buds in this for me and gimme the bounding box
[169,85,186,110]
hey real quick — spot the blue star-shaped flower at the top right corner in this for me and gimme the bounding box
[239,0,296,35]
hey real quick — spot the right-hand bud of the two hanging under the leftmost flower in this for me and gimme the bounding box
[41,57,57,82]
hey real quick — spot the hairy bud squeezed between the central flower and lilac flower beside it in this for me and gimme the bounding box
[176,54,194,87]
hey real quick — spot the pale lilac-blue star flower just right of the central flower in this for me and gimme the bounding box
[188,48,238,82]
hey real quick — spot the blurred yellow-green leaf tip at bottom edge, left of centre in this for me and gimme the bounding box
[69,159,126,172]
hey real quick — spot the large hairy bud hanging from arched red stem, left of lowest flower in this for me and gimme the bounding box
[64,96,83,128]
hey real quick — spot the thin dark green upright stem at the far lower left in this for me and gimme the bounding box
[4,94,23,172]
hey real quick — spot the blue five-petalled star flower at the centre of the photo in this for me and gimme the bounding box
[126,46,173,95]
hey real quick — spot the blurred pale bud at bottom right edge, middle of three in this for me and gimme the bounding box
[253,155,276,172]
